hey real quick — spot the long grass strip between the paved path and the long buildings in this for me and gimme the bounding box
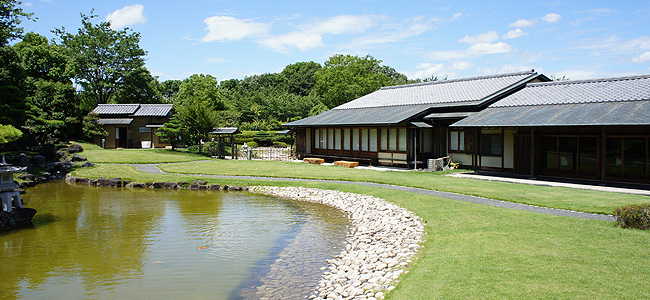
[159,160,650,214]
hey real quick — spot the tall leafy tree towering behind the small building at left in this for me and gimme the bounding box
[54,12,146,104]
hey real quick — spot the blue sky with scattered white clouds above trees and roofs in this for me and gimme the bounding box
[17,0,650,81]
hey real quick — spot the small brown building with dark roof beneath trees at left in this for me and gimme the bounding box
[93,104,173,148]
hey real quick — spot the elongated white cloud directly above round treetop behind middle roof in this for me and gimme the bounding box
[305,15,377,35]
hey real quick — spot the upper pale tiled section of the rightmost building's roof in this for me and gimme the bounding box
[490,75,650,107]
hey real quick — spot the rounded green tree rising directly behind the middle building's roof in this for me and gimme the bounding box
[314,54,392,108]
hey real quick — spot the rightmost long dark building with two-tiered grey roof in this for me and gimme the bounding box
[450,75,650,183]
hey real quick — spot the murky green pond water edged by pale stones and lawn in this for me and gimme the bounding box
[0,182,349,299]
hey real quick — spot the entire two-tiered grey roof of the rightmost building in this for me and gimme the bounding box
[451,75,650,127]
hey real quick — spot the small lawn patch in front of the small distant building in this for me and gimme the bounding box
[75,142,211,164]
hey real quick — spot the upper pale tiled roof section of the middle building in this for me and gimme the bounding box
[333,70,537,110]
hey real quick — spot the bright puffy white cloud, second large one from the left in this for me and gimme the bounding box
[200,16,269,43]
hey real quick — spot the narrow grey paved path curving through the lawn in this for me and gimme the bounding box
[131,164,616,221]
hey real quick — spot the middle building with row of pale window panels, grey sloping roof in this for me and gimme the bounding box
[283,70,549,167]
